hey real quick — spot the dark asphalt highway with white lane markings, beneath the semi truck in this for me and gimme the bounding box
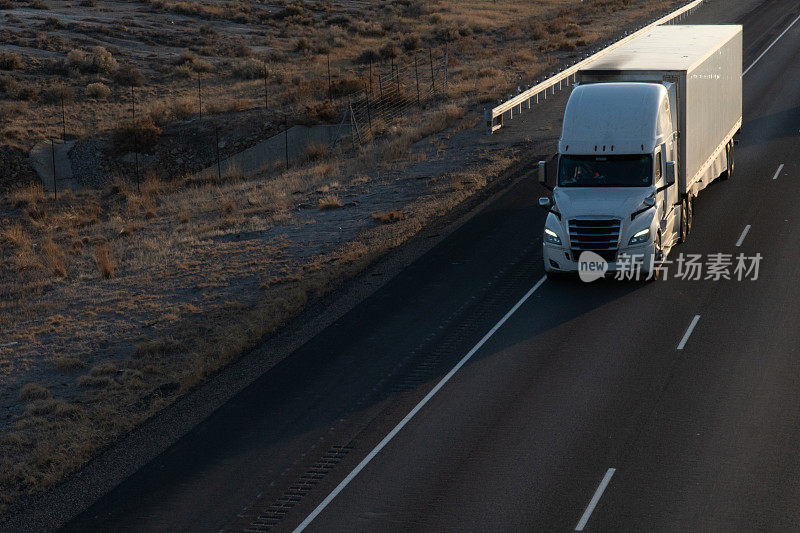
[65,0,800,531]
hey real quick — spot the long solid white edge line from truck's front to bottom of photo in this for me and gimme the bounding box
[294,276,547,533]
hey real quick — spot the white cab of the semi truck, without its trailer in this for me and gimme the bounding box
[540,82,681,274]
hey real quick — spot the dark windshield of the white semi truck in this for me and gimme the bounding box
[558,154,653,187]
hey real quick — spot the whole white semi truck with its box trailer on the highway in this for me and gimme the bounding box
[539,25,742,276]
